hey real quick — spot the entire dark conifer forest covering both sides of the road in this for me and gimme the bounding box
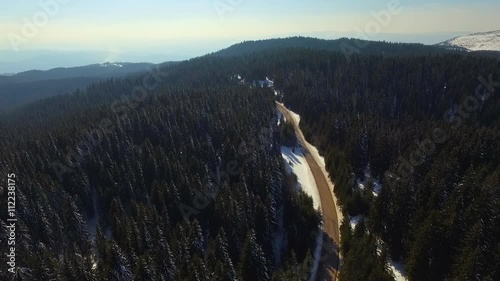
[0,37,500,281]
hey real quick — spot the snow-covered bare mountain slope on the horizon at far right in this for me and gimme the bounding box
[438,30,500,51]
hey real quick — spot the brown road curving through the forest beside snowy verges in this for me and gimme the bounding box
[277,103,340,281]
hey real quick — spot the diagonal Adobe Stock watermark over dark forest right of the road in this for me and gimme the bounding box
[384,66,500,187]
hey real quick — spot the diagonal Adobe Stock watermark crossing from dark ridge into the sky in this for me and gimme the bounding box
[340,0,404,62]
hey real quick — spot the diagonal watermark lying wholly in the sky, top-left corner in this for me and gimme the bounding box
[7,0,71,52]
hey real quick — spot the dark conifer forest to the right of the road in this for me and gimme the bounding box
[228,50,500,280]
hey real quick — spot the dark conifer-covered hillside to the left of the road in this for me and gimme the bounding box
[0,56,319,281]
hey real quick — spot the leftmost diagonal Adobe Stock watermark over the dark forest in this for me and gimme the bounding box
[51,66,168,183]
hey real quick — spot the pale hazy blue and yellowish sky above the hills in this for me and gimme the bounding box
[0,0,500,71]
